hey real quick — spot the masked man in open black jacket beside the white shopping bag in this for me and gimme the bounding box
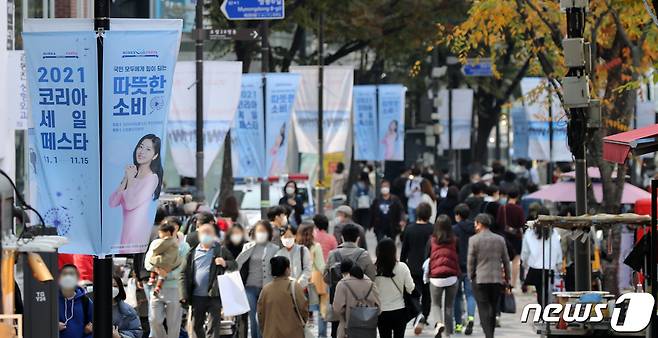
[180,223,237,338]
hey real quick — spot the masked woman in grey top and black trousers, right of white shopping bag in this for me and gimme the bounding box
[237,220,279,338]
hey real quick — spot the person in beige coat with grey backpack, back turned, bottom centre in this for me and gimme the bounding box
[332,259,381,338]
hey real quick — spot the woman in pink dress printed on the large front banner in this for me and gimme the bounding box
[110,134,163,253]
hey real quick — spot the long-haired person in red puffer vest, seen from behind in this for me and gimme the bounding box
[428,215,461,337]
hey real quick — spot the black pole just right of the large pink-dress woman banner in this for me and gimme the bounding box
[194,0,205,202]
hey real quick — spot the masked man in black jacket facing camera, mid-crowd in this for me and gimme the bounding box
[370,180,403,242]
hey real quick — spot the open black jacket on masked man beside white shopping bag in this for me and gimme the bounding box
[179,244,238,302]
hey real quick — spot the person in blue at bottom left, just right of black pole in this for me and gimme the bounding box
[112,276,142,338]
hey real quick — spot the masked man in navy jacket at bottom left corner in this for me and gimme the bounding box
[58,264,94,338]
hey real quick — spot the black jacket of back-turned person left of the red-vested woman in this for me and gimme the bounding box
[400,223,434,276]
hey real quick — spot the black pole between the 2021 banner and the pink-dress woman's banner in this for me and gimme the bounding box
[93,0,112,338]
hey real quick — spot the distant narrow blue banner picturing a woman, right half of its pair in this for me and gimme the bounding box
[377,84,407,161]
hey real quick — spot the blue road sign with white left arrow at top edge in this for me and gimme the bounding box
[222,0,285,20]
